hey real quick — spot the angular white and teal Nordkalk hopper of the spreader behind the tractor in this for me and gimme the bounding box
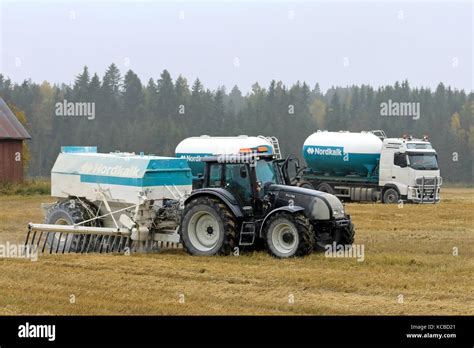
[51,146,192,204]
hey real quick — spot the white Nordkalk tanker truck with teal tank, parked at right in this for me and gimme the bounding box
[300,131,442,203]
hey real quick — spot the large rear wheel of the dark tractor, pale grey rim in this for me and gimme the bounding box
[181,197,237,256]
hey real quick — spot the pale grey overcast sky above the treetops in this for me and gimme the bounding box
[0,0,473,92]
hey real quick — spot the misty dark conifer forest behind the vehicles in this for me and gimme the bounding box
[0,64,474,184]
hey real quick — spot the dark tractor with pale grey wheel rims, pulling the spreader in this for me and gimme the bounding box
[180,154,354,258]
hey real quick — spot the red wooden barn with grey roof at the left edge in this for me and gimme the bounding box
[0,98,31,183]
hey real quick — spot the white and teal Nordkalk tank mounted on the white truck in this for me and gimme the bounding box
[303,131,382,177]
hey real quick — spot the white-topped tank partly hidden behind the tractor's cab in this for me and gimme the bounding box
[175,135,273,176]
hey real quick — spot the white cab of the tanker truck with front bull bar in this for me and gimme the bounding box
[379,137,442,203]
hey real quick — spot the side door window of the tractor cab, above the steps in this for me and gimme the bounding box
[225,163,252,206]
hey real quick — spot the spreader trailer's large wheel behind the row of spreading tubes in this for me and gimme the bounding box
[45,200,99,252]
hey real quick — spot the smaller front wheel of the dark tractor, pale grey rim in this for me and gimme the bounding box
[264,212,314,258]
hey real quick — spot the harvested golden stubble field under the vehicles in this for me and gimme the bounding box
[0,188,474,315]
